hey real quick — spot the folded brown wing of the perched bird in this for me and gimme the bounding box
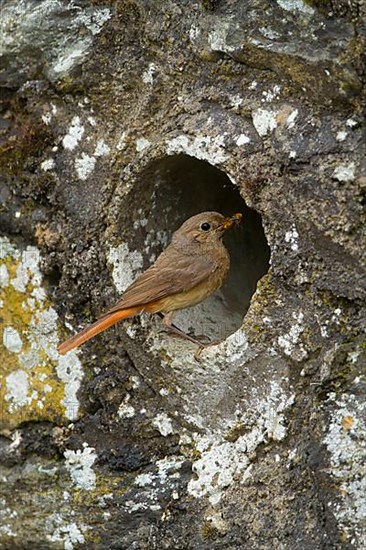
[106,247,218,315]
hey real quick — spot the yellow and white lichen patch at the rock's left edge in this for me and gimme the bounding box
[0,241,83,429]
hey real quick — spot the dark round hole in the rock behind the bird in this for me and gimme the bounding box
[120,154,269,340]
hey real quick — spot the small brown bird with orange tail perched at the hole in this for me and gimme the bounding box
[58,212,242,355]
